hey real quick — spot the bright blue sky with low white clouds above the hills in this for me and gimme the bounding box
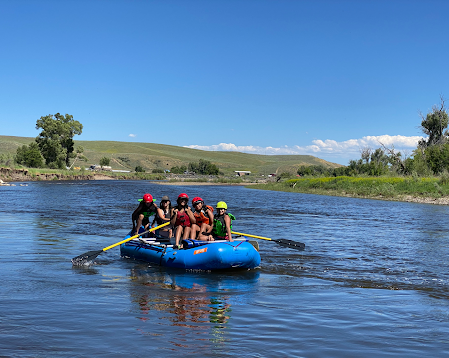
[0,0,449,164]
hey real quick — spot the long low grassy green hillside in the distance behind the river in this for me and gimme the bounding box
[0,136,341,175]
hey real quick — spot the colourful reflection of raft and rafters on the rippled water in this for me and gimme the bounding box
[126,267,259,344]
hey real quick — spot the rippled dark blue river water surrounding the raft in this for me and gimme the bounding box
[0,181,449,357]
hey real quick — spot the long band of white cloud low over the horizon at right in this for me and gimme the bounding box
[185,135,422,158]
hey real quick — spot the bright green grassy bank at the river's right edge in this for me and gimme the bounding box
[251,175,449,204]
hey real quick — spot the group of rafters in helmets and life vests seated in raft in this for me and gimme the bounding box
[132,193,235,247]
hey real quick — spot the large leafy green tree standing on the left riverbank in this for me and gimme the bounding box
[36,113,83,169]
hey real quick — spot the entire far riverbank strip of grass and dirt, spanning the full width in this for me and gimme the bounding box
[5,164,449,205]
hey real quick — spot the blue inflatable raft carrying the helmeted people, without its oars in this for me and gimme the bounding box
[120,231,260,270]
